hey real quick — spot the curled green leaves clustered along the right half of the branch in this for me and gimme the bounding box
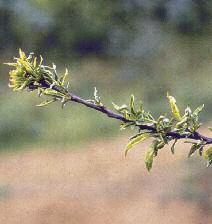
[113,94,212,171]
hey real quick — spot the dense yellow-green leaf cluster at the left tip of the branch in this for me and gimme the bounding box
[5,49,70,107]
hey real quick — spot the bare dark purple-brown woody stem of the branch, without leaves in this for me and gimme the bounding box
[70,93,212,144]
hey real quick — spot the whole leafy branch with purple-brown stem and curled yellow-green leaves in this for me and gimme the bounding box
[4,50,212,170]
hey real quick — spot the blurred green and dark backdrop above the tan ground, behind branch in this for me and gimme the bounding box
[0,0,212,150]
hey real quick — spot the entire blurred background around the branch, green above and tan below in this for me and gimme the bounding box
[0,0,212,224]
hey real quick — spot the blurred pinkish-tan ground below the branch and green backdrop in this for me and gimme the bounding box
[0,129,212,224]
